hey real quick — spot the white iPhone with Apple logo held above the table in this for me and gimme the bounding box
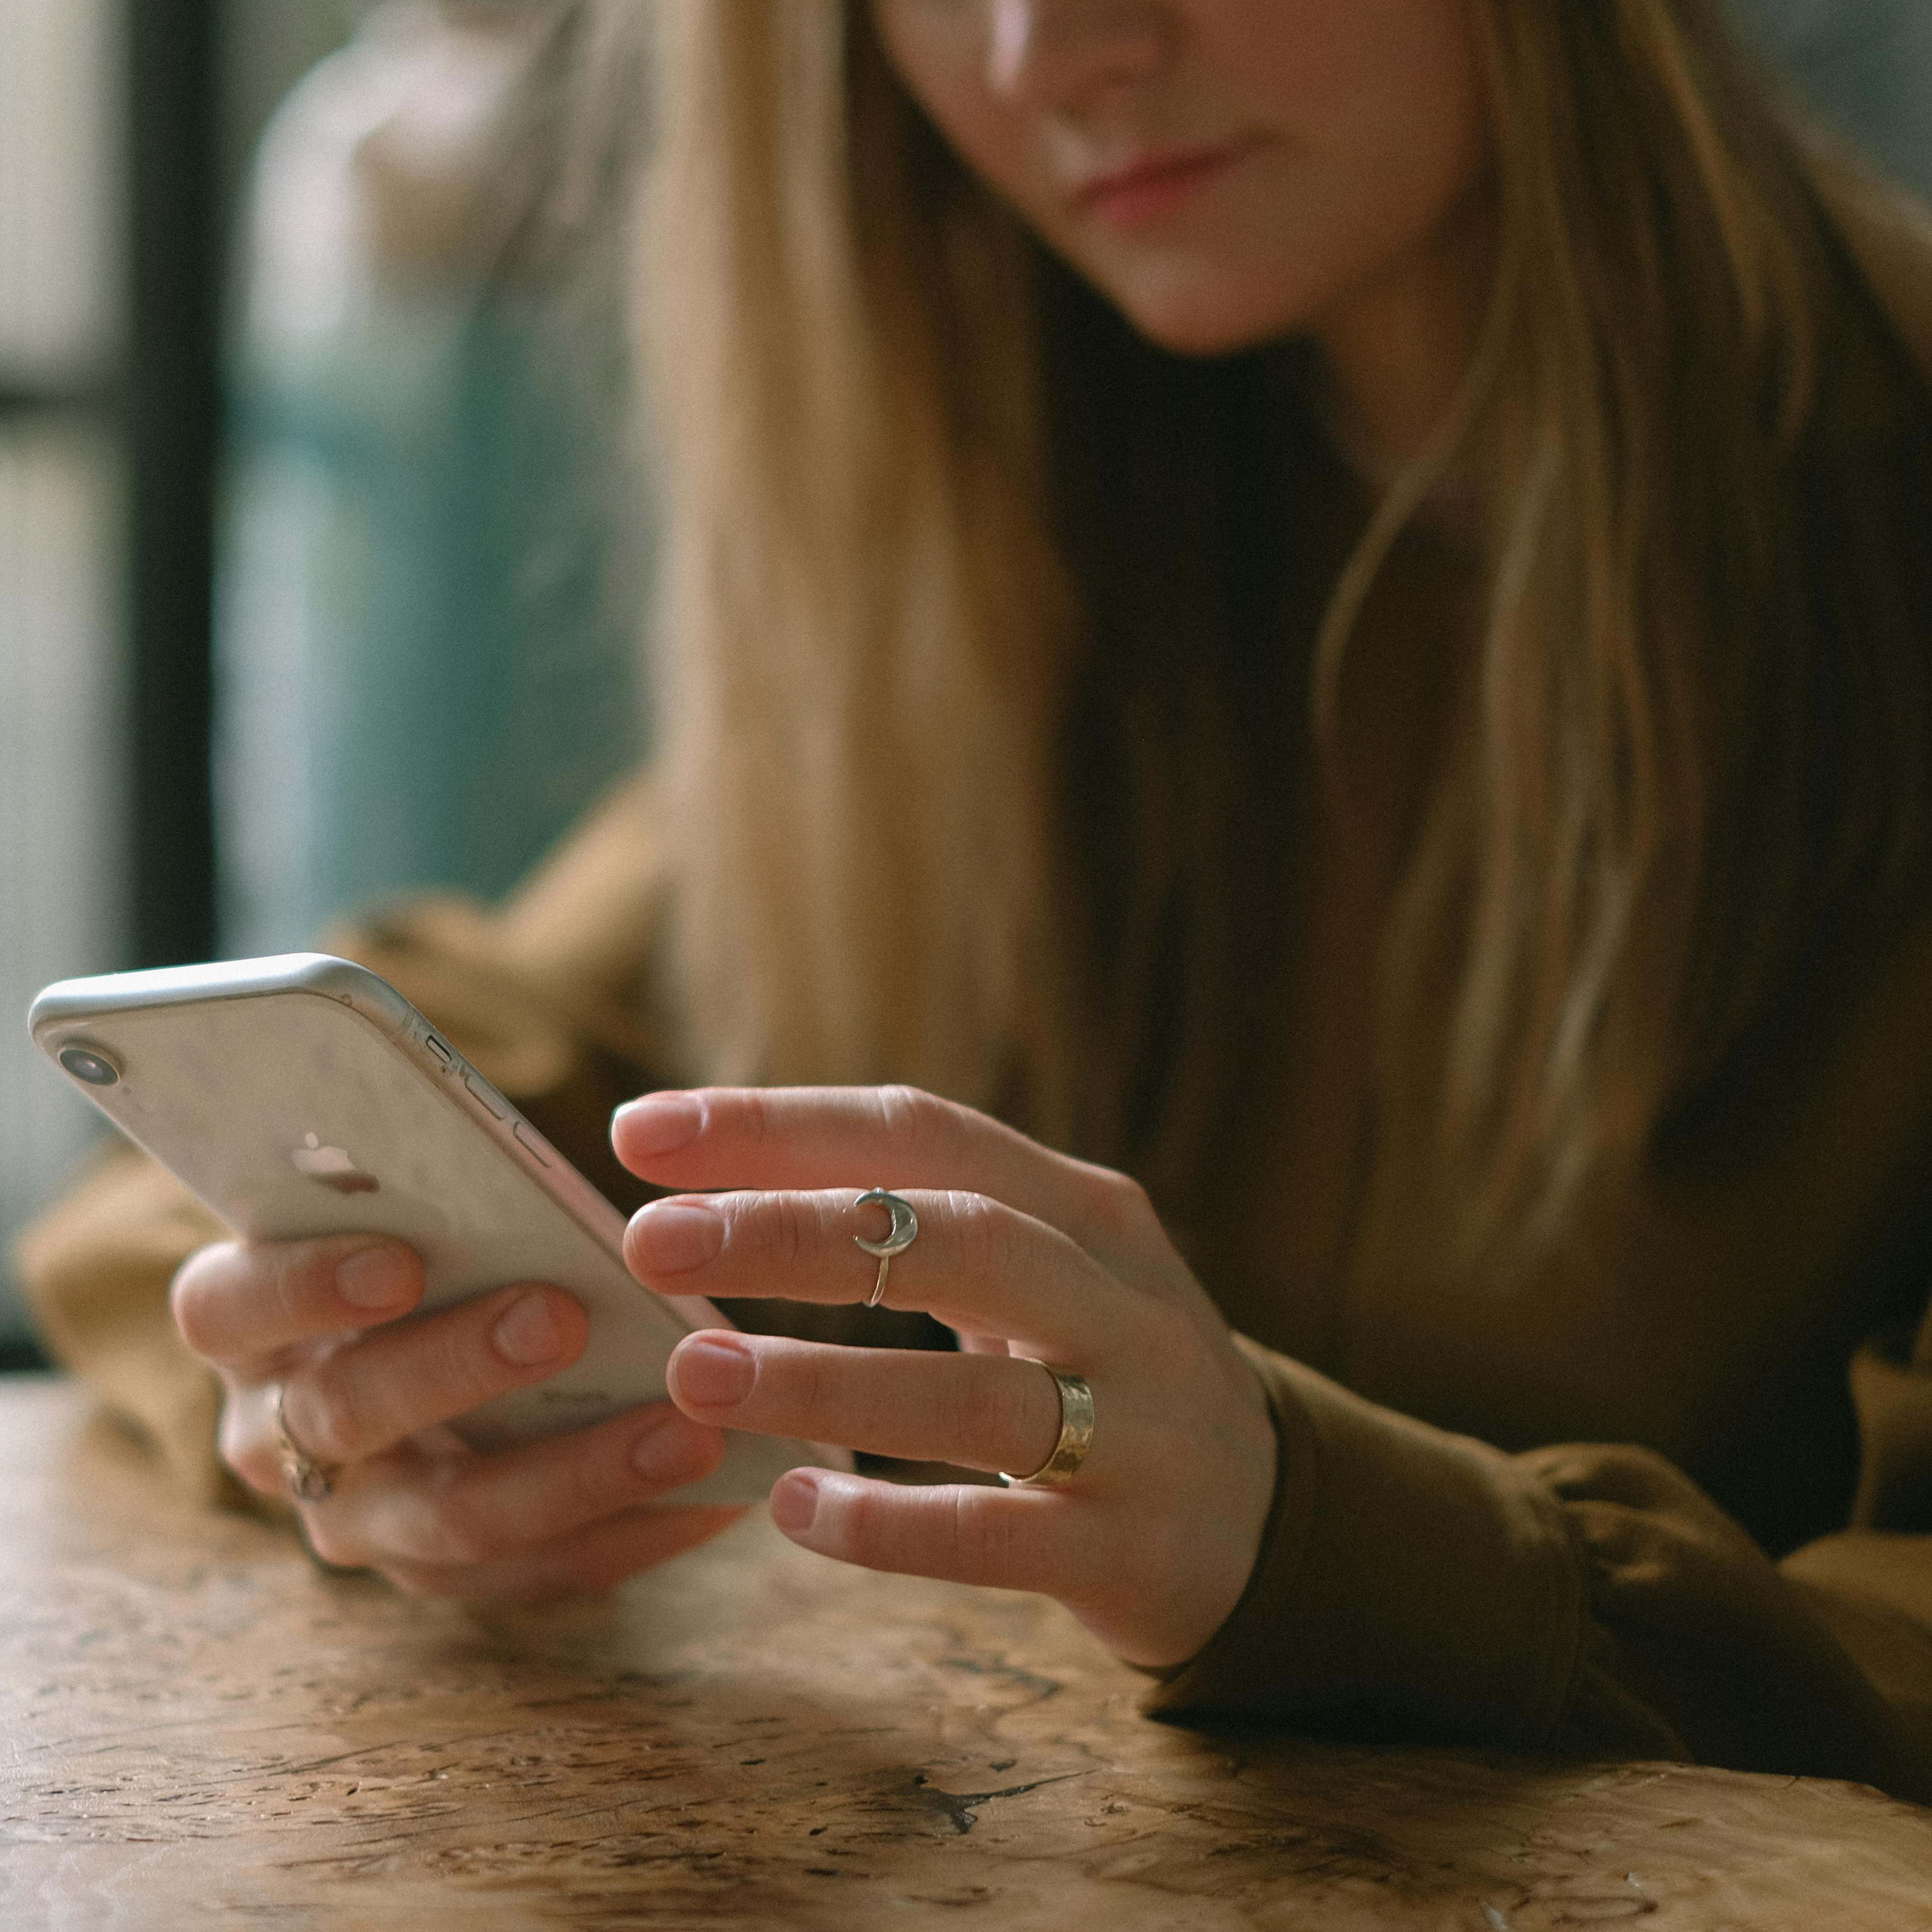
[27,953,852,1505]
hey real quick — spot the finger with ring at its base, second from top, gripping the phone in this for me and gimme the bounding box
[282,1287,589,1462]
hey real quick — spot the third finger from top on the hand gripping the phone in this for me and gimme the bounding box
[309,1403,724,1569]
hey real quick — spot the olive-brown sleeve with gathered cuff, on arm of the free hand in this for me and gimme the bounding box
[1146,1322,1932,1803]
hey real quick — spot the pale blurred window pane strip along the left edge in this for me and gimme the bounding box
[0,0,128,1347]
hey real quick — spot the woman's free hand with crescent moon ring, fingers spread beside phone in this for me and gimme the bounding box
[612,1088,1275,1667]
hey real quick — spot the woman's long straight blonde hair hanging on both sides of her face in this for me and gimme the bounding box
[640,11,1932,1266]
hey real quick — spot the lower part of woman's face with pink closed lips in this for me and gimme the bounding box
[872,0,1488,353]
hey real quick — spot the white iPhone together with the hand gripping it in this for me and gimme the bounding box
[29,954,850,1596]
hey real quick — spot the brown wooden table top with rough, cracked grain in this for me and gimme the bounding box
[0,1379,1932,1932]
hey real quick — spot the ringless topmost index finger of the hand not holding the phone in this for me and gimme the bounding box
[610,1086,1157,1248]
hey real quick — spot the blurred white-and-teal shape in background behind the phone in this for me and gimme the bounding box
[216,0,651,953]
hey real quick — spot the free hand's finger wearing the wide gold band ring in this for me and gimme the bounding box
[666,1331,1060,1474]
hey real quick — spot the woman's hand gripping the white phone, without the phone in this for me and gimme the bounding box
[172,1235,742,1602]
